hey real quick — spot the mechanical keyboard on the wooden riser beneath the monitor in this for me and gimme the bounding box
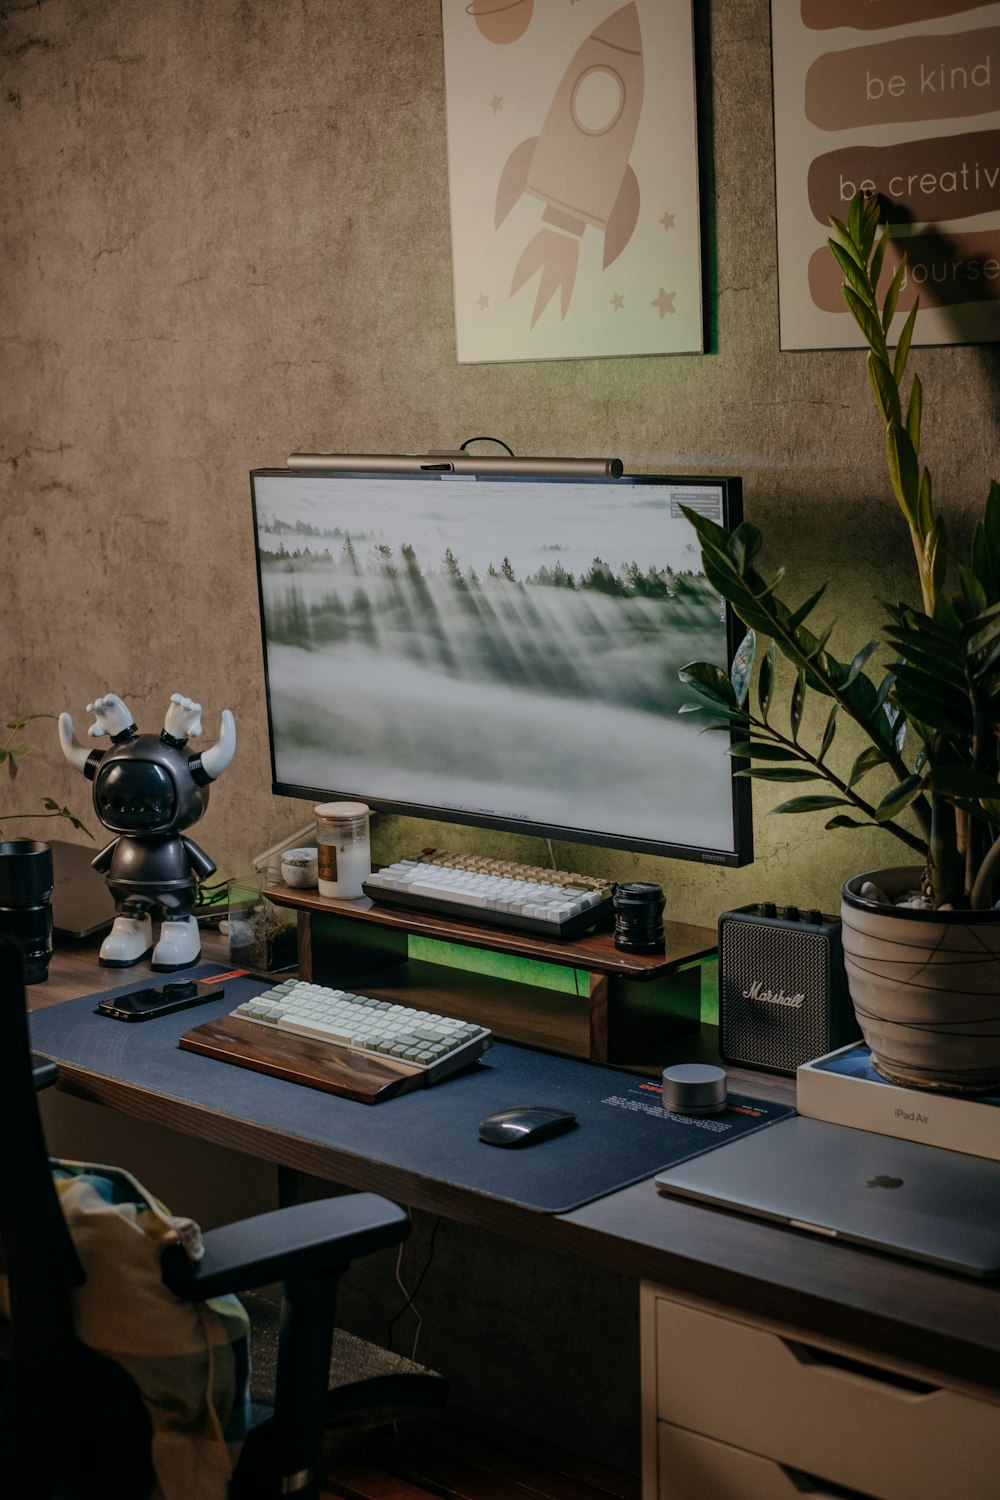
[363,855,613,938]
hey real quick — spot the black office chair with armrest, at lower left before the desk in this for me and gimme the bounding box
[0,938,447,1500]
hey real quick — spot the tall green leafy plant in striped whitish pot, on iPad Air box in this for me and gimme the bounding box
[681,195,1000,1091]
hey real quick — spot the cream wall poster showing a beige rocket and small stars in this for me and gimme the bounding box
[442,0,703,365]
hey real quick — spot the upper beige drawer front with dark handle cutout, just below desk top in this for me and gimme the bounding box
[655,1298,1000,1500]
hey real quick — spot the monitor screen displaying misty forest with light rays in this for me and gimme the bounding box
[250,459,751,864]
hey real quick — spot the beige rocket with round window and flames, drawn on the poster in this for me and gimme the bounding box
[496,3,643,329]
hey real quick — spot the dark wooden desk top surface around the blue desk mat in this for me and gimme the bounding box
[28,933,1000,1397]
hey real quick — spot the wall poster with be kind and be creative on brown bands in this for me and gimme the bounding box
[771,0,1000,350]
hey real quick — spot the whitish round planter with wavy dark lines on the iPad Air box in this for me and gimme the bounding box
[841,867,1000,1092]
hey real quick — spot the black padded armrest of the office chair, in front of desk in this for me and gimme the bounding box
[160,1193,409,1302]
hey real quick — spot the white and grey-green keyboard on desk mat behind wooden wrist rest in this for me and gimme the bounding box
[229,980,492,1083]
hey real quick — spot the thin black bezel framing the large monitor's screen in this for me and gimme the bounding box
[250,455,754,869]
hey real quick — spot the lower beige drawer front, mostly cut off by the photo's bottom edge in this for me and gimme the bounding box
[657,1422,864,1500]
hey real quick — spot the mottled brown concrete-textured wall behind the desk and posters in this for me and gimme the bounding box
[0,0,999,923]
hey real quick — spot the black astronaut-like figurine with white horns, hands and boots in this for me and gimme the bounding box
[58,693,235,974]
